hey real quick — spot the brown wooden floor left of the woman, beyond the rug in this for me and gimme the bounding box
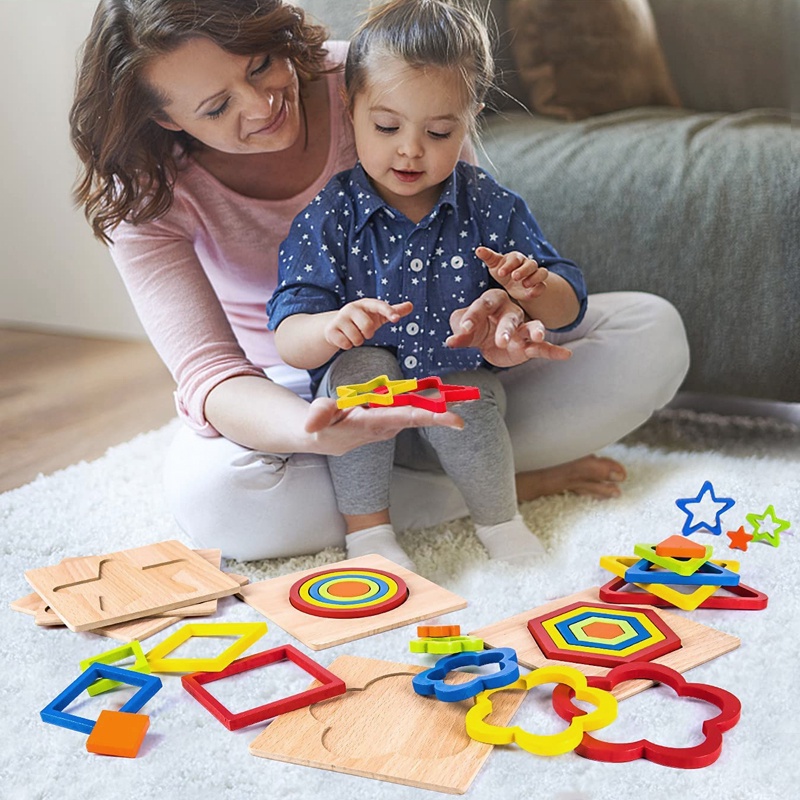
[0,329,175,492]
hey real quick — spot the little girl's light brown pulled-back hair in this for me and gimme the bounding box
[345,0,494,126]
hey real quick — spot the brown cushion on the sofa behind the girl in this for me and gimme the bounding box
[507,0,680,120]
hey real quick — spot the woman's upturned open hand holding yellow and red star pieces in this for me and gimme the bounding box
[305,397,464,456]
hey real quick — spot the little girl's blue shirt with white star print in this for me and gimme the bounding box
[267,161,586,391]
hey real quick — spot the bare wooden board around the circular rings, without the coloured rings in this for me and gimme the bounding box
[238,555,467,650]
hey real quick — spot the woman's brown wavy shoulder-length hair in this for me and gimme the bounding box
[69,0,327,243]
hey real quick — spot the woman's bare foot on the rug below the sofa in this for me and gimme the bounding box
[517,456,625,502]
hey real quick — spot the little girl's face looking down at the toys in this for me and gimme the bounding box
[352,58,478,221]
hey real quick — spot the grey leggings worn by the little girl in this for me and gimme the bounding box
[317,345,517,525]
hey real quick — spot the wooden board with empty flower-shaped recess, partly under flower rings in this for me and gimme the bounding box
[250,656,525,794]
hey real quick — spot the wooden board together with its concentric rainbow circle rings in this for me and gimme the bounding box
[239,555,467,650]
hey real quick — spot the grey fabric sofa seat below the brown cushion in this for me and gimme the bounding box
[483,109,800,402]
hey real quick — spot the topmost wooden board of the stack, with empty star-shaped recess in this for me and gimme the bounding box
[25,540,240,631]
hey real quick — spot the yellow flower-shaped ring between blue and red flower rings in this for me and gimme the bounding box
[466,666,617,756]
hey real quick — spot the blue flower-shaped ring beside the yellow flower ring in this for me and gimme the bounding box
[411,647,519,703]
